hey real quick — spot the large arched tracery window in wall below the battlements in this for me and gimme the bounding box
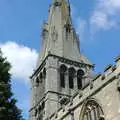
[79,100,105,120]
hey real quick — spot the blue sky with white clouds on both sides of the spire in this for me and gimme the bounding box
[0,0,120,120]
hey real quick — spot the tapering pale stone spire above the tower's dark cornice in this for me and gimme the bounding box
[37,0,91,67]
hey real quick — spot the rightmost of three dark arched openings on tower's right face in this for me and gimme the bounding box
[77,69,85,89]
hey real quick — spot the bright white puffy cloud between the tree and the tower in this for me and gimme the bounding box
[0,41,38,82]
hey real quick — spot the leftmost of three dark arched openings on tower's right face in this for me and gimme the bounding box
[60,65,67,88]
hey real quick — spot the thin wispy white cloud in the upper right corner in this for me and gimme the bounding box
[90,0,120,30]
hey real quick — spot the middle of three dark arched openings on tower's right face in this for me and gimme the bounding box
[68,68,76,89]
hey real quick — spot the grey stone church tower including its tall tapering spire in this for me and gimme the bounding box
[30,0,94,120]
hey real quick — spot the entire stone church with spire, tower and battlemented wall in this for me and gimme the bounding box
[29,0,120,120]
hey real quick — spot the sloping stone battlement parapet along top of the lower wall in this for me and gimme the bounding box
[47,56,120,120]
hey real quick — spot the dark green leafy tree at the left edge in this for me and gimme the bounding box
[0,50,23,120]
